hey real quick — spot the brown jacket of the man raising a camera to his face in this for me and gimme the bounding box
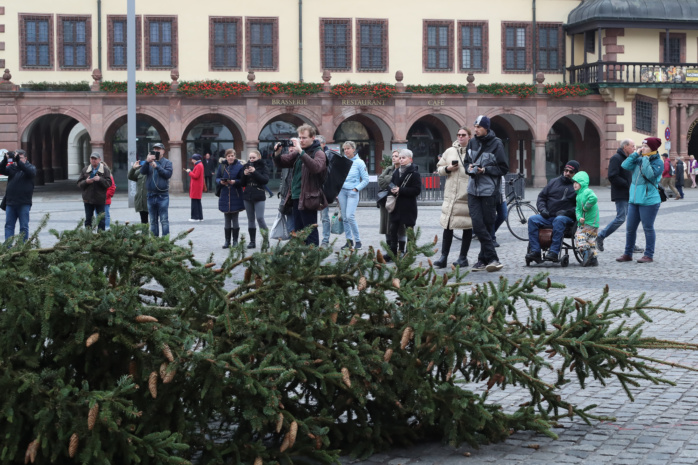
[274,140,327,211]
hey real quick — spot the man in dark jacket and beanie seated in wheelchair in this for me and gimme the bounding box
[526,160,579,263]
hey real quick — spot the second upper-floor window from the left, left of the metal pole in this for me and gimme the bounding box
[58,16,92,69]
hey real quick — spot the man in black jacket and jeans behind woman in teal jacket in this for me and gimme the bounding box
[596,139,644,252]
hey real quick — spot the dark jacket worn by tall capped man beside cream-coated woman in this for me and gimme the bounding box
[465,129,509,197]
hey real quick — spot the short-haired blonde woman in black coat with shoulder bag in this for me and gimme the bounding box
[385,149,422,261]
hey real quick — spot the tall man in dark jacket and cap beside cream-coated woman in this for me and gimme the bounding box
[464,115,509,272]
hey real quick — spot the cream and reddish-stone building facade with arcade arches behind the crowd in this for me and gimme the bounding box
[0,0,698,189]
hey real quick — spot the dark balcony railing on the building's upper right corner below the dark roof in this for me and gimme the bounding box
[567,61,698,85]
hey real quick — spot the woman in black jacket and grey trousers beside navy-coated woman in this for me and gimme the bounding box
[242,150,269,249]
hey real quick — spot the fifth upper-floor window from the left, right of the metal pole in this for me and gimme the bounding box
[209,17,242,70]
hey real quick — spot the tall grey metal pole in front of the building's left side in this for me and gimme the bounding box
[126,0,137,208]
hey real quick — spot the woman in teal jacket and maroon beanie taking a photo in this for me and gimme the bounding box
[616,137,664,263]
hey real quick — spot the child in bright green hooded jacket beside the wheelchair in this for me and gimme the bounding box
[572,171,599,266]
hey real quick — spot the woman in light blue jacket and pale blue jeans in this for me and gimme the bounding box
[337,140,368,250]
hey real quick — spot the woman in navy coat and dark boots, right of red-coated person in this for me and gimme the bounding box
[216,149,245,249]
